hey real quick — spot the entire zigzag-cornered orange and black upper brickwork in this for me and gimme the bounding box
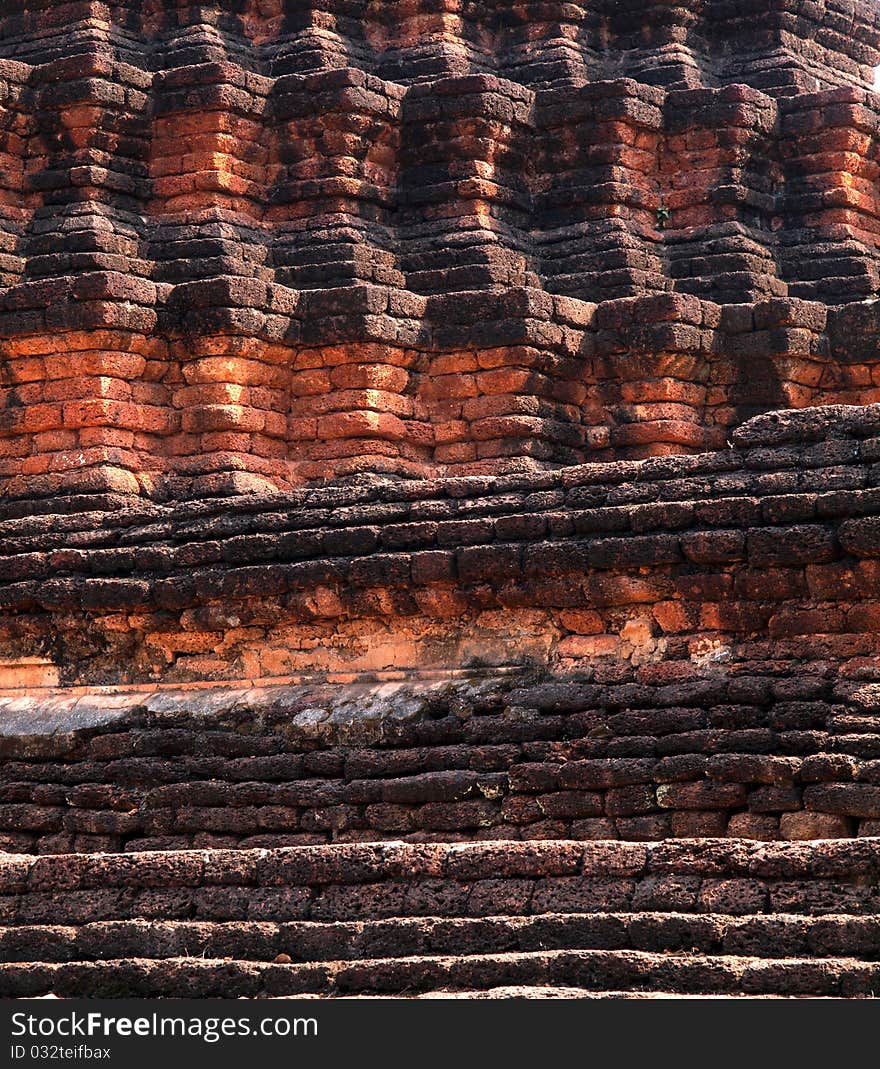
[0,0,880,489]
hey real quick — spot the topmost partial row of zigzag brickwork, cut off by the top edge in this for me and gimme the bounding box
[0,0,878,95]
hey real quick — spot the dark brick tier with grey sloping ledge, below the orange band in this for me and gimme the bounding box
[8,663,880,854]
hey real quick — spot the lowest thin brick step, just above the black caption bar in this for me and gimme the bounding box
[0,950,880,998]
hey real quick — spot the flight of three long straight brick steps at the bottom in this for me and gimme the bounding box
[6,839,880,997]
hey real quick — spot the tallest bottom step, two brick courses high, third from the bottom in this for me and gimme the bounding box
[6,837,880,925]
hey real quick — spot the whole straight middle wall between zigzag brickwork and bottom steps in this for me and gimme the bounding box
[0,406,880,851]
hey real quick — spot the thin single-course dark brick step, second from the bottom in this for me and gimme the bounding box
[0,911,880,964]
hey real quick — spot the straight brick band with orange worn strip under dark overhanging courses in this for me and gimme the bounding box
[0,406,880,685]
